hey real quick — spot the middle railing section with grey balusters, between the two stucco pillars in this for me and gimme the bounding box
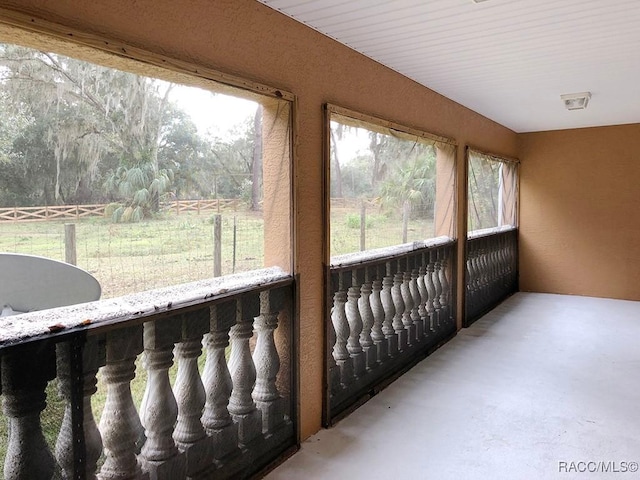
[325,237,456,424]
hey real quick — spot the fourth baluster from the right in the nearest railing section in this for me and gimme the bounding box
[173,308,213,477]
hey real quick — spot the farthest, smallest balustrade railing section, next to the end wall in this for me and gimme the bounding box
[465,227,518,326]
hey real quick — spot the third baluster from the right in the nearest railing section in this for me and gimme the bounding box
[202,301,239,463]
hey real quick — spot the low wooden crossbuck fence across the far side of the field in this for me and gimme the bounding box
[0,198,242,222]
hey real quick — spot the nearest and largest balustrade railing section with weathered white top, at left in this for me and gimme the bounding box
[0,268,297,480]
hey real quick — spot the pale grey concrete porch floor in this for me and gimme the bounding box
[266,293,640,480]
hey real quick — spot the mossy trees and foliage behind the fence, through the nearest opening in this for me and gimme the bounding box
[0,44,262,221]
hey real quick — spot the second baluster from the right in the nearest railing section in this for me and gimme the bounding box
[229,293,263,448]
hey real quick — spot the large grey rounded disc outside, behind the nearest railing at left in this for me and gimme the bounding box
[0,253,101,315]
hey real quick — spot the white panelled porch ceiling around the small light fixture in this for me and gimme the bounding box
[259,0,640,132]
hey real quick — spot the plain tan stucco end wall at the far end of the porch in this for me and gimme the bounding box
[520,124,640,300]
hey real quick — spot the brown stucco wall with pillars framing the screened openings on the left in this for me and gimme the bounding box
[0,0,517,438]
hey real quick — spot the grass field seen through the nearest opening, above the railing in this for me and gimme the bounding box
[0,211,264,298]
